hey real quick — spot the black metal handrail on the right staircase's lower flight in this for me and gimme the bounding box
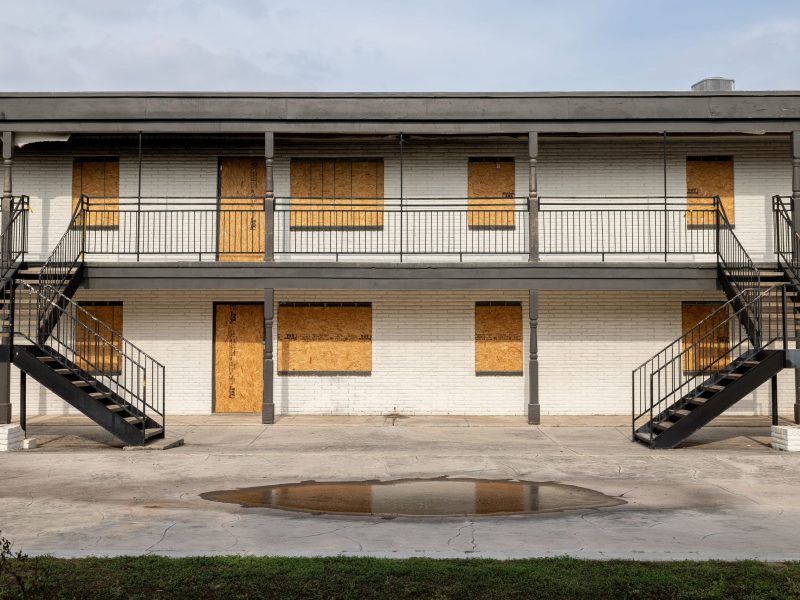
[632,284,797,441]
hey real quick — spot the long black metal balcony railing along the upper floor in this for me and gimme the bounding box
[76,196,719,261]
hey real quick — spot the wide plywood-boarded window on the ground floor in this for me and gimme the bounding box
[278,302,372,375]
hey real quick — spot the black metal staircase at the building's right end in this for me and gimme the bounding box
[632,199,800,448]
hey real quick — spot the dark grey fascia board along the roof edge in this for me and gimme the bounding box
[0,91,800,131]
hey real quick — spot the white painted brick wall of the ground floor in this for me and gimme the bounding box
[12,290,794,415]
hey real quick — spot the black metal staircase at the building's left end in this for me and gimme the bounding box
[0,199,165,445]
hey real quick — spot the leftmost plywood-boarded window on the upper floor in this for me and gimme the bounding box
[72,158,119,229]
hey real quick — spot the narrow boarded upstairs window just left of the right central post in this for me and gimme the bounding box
[467,158,515,229]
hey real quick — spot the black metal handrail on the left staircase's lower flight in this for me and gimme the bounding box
[10,280,166,440]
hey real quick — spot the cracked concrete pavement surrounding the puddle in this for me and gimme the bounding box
[0,415,800,560]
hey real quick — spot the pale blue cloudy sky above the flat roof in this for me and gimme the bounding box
[0,0,800,92]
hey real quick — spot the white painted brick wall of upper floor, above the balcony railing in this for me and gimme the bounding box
[14,136,791,260]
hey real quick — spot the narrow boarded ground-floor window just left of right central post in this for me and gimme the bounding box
[475,302,522,375]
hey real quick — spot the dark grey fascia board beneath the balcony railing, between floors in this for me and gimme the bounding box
[82,262,718,291]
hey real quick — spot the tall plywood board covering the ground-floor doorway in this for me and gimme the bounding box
[214,304,264,413]
